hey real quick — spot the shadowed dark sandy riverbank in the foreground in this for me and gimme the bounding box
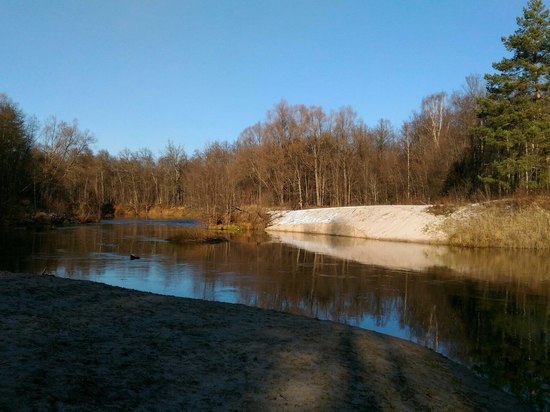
[0,273,524,411]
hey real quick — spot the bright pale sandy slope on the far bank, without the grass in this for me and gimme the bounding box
[266,205,447,244]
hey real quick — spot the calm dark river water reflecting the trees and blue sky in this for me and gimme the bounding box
[0,221,550,409]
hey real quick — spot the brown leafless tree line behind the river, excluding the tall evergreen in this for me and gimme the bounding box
[0,77,482,222]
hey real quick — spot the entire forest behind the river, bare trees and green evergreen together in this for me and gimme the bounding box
[0,0,550,223]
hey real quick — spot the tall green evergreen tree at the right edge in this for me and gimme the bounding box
[476,0,550,193]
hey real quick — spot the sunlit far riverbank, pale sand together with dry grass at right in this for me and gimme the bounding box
[266,197,550,250]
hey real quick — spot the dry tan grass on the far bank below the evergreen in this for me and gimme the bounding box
[443,199,550,249]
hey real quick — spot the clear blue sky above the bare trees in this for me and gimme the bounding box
[0,0,536,155]
